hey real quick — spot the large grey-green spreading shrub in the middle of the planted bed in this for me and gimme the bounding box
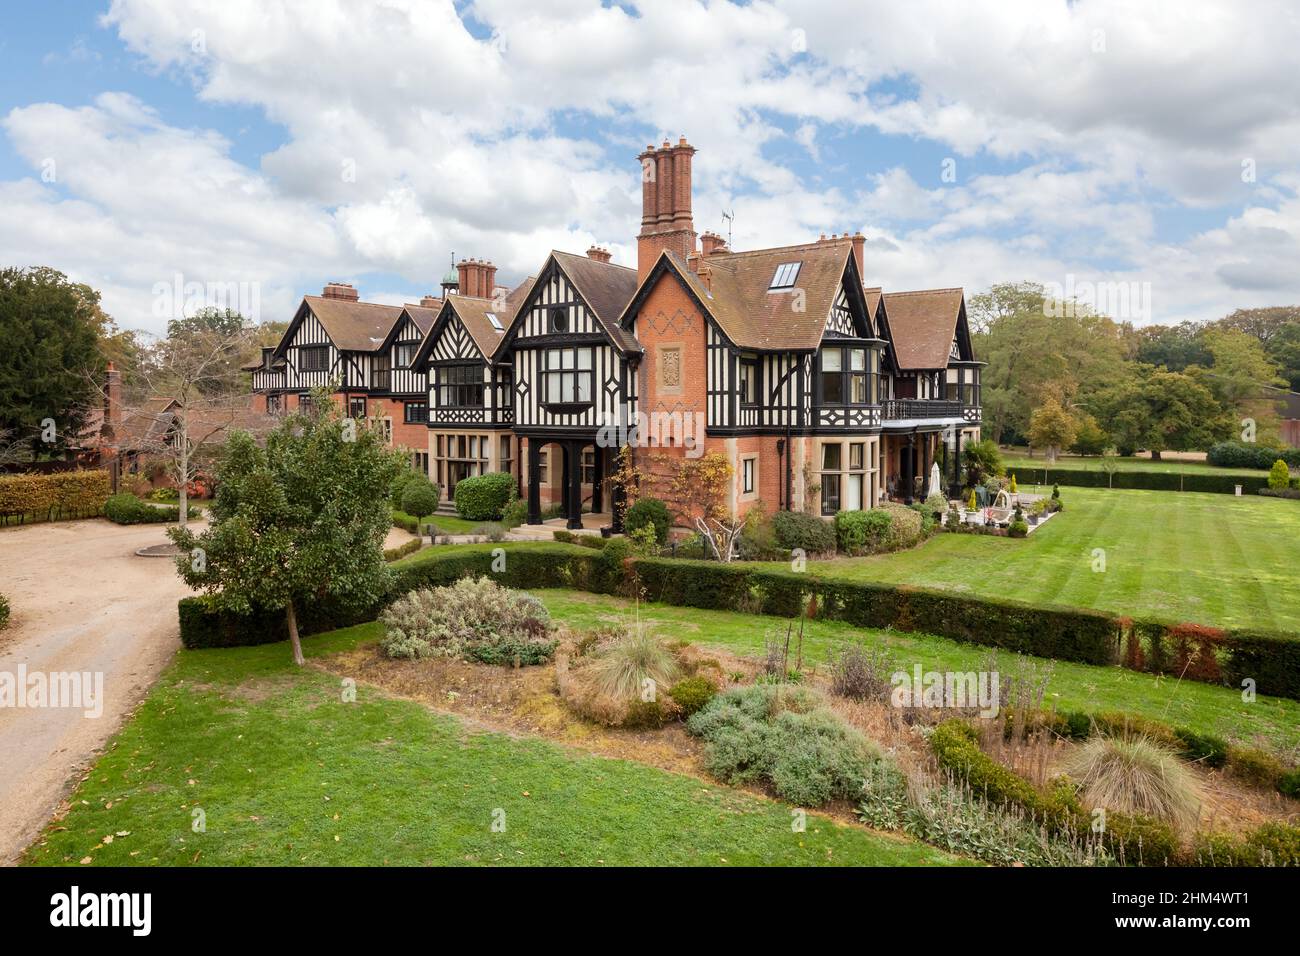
[686,684,880,806]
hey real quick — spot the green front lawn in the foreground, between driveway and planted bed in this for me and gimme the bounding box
[23,624,963,866]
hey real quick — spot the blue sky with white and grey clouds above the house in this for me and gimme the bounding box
[0,0,1300,330]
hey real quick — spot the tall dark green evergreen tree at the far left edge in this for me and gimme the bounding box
[0,267,103,453]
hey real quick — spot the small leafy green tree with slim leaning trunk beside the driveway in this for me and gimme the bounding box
[168,392,402,665]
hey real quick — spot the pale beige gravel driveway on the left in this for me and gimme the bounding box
[0,520,412,864]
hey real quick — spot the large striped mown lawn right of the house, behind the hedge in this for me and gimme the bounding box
[790,483,1300,632]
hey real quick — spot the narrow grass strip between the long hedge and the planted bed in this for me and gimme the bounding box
[534,591,1300,752]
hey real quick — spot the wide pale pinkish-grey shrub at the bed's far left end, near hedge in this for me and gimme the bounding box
[380,578,555,665]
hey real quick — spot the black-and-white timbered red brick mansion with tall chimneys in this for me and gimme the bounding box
[254,138,983,528]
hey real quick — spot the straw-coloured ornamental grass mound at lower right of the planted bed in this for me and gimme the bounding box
[1066,736,1200,830]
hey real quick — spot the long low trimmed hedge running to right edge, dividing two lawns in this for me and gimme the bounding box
[182,546,1300,700]
